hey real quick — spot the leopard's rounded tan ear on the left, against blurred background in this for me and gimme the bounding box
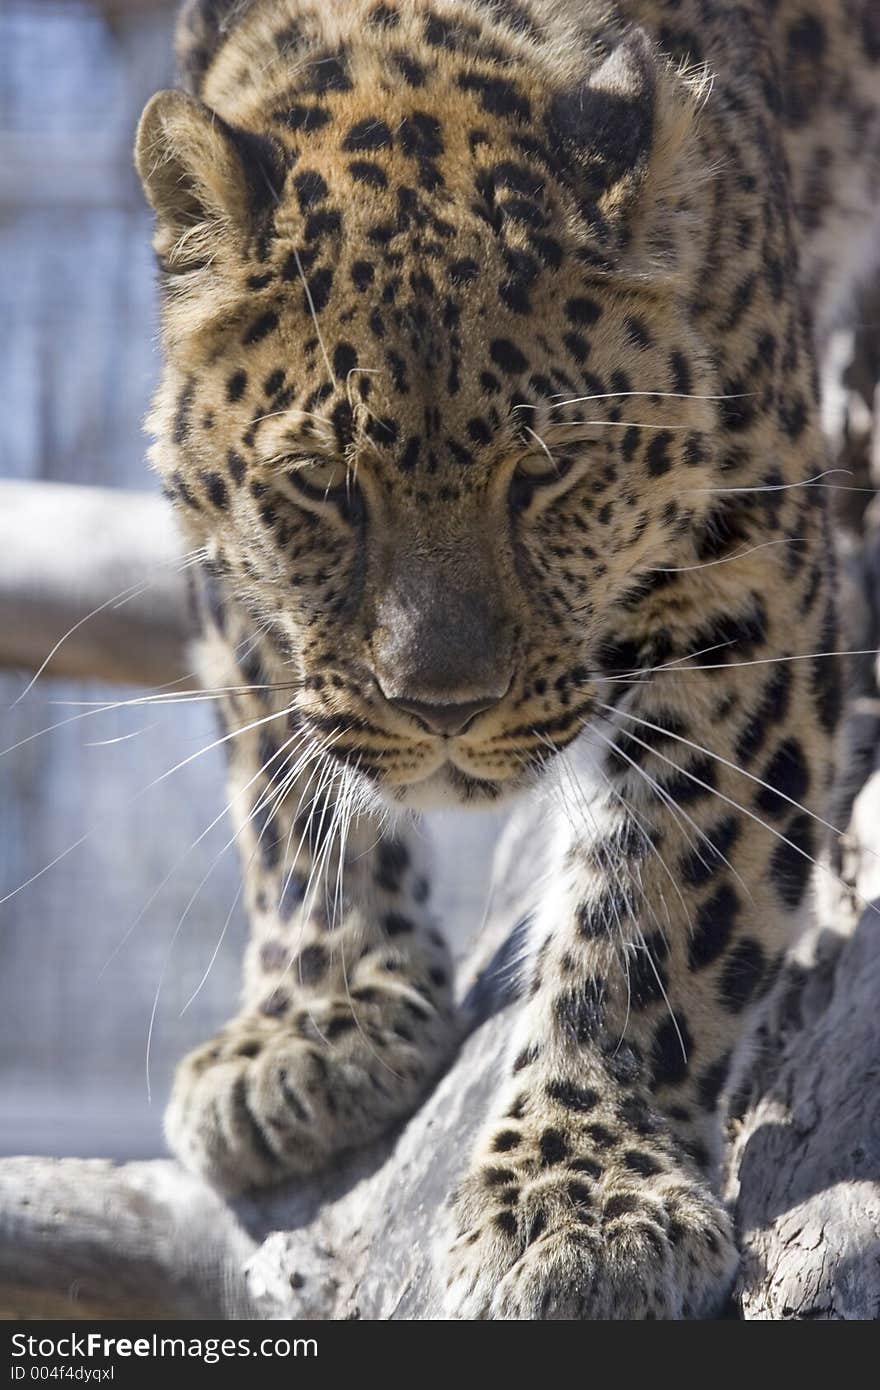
[135,92,281,270]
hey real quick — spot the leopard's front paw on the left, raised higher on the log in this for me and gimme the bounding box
[165,999,452,1193]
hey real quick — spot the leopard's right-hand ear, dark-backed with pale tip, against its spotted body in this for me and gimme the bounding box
[551,26,703,260]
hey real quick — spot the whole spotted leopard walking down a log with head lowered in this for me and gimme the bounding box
[135,0,880,1321]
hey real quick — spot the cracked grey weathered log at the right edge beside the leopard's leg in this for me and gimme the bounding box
[733,899,880,1319]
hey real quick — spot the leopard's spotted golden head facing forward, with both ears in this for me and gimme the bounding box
[138,4,716,805]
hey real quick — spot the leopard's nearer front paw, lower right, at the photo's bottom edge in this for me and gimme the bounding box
[443,1169,737,1321]
